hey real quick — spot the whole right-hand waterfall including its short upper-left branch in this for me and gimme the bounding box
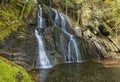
[52,9,81,63]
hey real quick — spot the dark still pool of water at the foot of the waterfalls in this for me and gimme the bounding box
[39,61,120,82]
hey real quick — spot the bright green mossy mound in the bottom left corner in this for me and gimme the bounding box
[0,57,34,82]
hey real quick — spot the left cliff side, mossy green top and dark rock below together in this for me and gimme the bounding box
[0,0,38,70]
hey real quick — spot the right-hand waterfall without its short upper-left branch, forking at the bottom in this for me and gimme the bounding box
[60,13,81,63]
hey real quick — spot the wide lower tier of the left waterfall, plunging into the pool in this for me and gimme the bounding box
[35,30,51,68]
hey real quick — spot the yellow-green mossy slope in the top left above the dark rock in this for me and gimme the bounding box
[0,0,32,41]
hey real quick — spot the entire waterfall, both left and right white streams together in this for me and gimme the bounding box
[35,5,81,68]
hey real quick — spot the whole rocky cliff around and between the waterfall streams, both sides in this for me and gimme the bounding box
[0,0,120,70]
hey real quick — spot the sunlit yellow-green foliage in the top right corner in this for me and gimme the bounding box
[104,0,120,27]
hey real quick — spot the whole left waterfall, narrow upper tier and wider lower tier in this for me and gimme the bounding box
[35,5,51,68]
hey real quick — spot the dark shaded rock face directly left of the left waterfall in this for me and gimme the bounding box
[0,26,37,70]
